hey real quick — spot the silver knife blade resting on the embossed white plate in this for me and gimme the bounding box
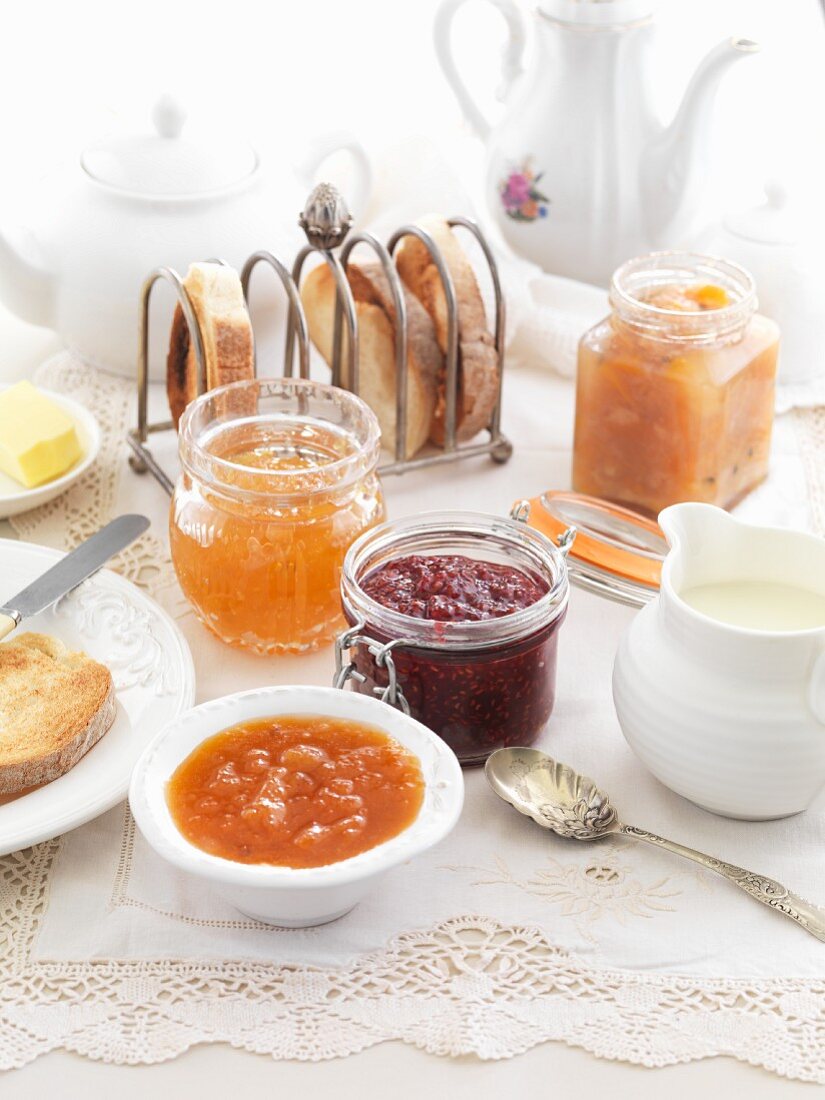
[0,515,150,640]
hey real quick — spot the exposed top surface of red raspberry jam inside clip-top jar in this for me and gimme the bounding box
[362,554,550,623]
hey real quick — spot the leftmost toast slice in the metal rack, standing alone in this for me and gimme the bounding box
[166,264,255,428]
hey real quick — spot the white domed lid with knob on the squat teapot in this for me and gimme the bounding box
[80,96,259,198]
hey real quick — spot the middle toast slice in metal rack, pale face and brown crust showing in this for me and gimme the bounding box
[301,263,444,459]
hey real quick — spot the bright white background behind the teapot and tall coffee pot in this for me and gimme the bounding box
[0,0,825,242]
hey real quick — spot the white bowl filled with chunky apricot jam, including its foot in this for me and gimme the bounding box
[129,686,464,927]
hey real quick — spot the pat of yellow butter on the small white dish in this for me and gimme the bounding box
[0,382,83,488]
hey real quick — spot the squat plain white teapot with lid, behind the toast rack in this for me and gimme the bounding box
[0,97,370,378]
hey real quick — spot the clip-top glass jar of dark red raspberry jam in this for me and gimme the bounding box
[337,512,569,765]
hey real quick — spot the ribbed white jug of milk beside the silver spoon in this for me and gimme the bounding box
[613,504,825,820]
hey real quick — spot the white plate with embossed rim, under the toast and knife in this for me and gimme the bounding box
[0,539,195,855]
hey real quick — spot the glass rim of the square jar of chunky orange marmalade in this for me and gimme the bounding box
[609,251,758,340]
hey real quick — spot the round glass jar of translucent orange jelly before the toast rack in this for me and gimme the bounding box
[169,378,384,653]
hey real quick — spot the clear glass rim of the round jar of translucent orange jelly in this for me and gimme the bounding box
[178,378,381,499]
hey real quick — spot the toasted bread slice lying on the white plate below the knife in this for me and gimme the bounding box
[0,634,116,794]
